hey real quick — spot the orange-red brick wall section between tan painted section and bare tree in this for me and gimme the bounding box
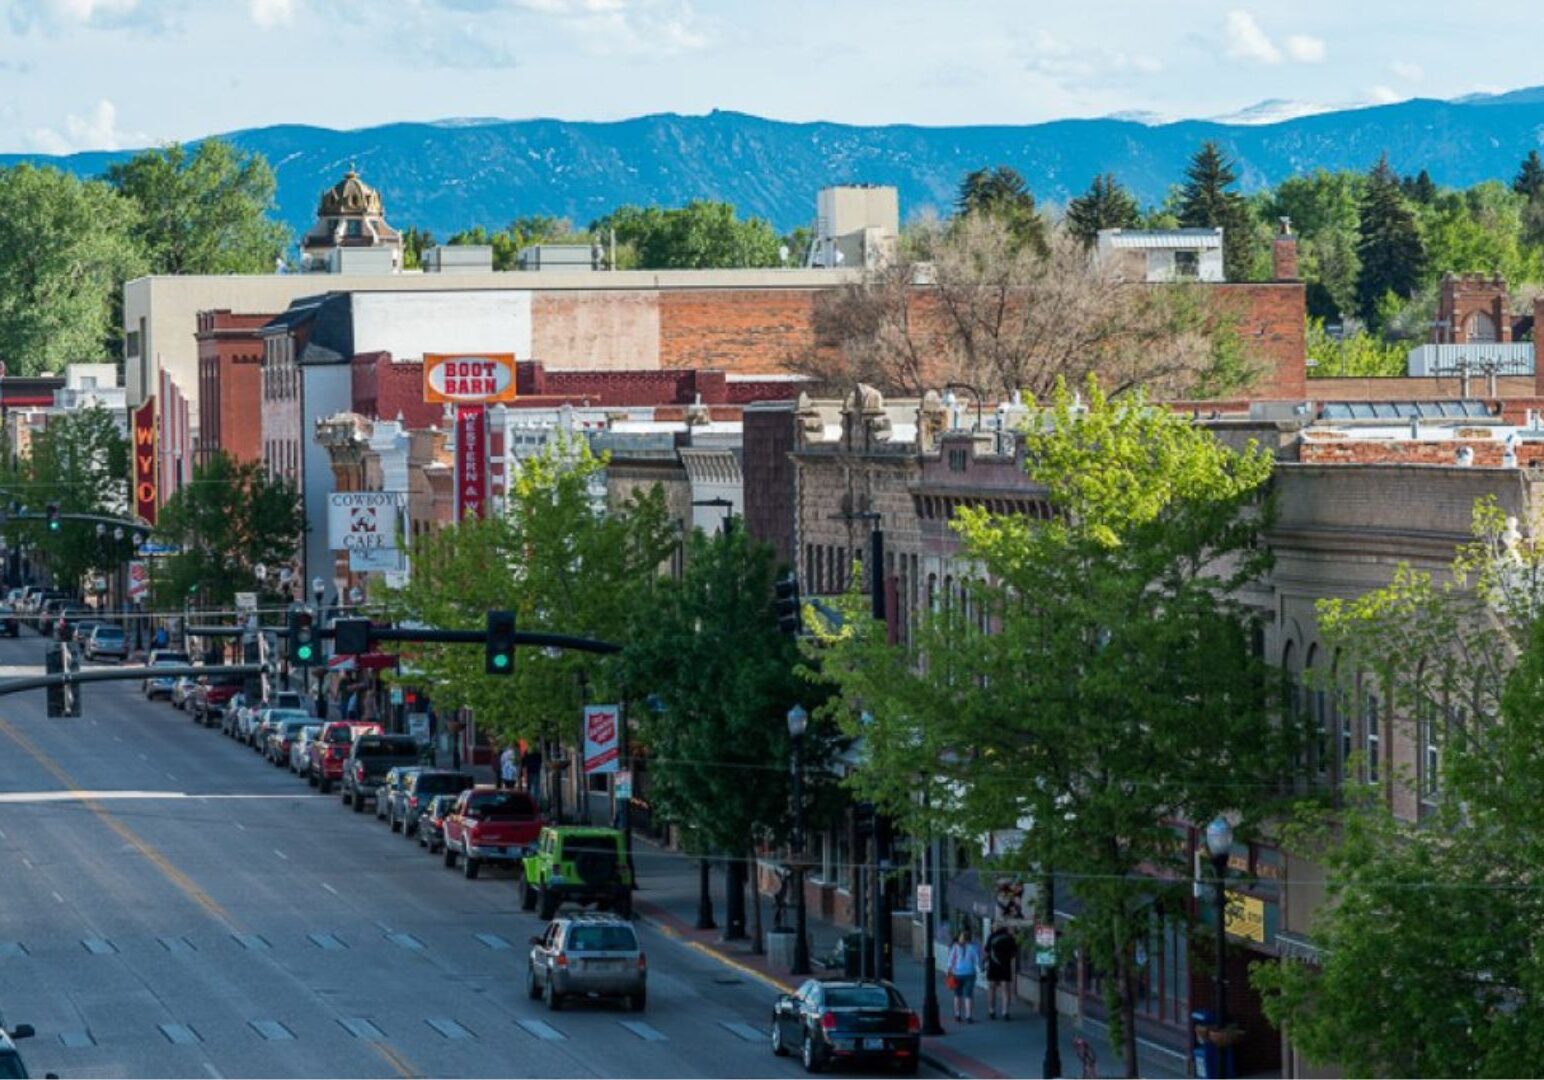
[659,289,815,375]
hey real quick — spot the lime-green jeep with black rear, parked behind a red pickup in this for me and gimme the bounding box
[520,825,633,919]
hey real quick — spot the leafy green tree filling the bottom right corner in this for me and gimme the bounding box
[1252,501,1544,1077]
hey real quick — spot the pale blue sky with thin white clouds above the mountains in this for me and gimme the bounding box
[0,0,1544,153]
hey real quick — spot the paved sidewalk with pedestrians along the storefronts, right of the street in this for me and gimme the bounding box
[633,837,1183,1078]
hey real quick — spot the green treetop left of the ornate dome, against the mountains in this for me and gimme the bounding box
[107,139,290,273]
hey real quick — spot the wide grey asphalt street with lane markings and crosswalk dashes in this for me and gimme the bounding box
[0,632,926,1077]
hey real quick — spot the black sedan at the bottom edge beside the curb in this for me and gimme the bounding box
[772,980,922,1074]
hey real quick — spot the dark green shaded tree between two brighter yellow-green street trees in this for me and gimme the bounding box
[627,528,831,920]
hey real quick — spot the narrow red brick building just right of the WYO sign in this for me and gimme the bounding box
[193,311,273,462]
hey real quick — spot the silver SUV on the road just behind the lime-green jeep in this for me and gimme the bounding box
[525,913,648,1012]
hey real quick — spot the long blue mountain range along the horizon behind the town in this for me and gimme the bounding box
[0,87,1544,238]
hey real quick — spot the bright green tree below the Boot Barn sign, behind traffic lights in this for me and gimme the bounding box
[384,440,673,757]
